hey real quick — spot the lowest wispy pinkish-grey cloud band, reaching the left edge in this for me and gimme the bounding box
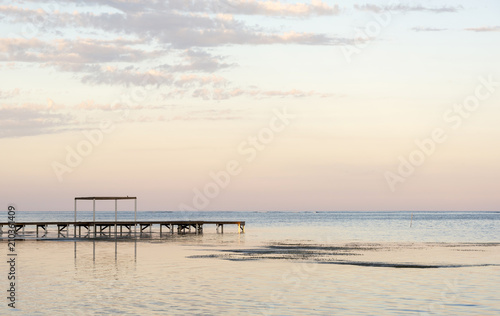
[0,99,248,138]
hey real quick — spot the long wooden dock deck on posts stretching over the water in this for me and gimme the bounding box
[0,221,245,237]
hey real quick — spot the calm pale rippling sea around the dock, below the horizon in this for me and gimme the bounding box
[0,210,500,315]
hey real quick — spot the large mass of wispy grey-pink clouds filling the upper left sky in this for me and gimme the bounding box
[0,0,348,100]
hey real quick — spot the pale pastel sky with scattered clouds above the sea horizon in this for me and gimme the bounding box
[0,0,500,211]
